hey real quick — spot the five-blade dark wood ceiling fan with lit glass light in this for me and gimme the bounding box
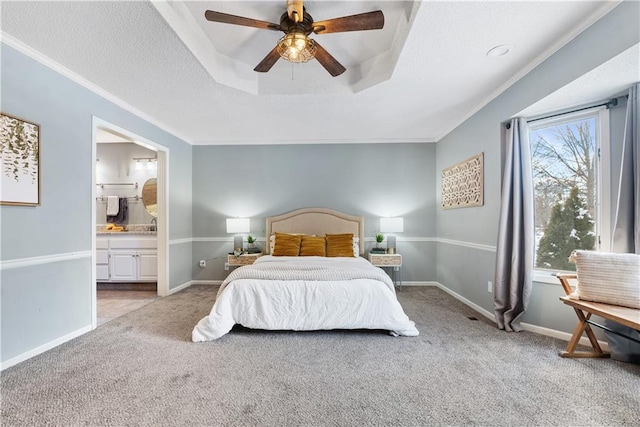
[204,0,384,77]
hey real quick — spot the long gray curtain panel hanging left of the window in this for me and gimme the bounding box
[493,118,535,332]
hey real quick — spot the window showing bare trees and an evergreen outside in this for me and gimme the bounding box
[529,108,609,272]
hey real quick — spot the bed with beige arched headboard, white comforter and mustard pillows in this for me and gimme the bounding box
[192,208,419,342]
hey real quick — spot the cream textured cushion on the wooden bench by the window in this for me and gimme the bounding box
[574,251,640,308]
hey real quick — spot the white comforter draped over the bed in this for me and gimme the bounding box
[192,255,418,342]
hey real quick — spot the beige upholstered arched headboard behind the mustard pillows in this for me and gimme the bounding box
[265,208,364,254]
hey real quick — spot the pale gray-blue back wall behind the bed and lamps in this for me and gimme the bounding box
[193,144,436,281]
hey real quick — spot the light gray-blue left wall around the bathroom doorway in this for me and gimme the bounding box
[0,44,191,362]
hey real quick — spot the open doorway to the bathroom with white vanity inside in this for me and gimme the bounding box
[92,118,168,328]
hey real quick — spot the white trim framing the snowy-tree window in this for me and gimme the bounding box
[527,105,612,285]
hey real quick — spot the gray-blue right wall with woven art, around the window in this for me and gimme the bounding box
[436,2,640,332]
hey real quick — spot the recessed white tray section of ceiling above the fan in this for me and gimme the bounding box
[153,0,420,95]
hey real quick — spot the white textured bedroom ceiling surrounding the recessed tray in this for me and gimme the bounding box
[2,0,616,144]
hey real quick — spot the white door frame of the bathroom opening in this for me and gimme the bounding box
[91,116,169,329]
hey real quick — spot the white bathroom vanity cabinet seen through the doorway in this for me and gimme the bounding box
[96,237,158,282]
